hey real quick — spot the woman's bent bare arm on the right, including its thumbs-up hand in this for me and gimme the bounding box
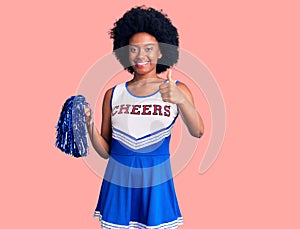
[160,70,204,138]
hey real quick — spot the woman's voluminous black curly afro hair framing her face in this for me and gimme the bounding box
[110,6,179,73]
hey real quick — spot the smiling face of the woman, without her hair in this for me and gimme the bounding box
[129,32,162,75]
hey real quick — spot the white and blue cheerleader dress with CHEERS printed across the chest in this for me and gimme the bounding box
[94,82,183,229]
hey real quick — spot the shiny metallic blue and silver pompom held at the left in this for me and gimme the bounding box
[55,95,91,157]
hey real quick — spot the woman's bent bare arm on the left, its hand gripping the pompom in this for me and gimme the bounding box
[86,88,112,159]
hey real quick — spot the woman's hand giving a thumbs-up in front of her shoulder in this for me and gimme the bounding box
[159,69,186,104]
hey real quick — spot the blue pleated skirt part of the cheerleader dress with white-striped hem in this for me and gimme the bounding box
[94,142,183,229]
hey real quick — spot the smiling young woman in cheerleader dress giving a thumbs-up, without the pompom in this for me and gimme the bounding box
[86,7,204,229]
